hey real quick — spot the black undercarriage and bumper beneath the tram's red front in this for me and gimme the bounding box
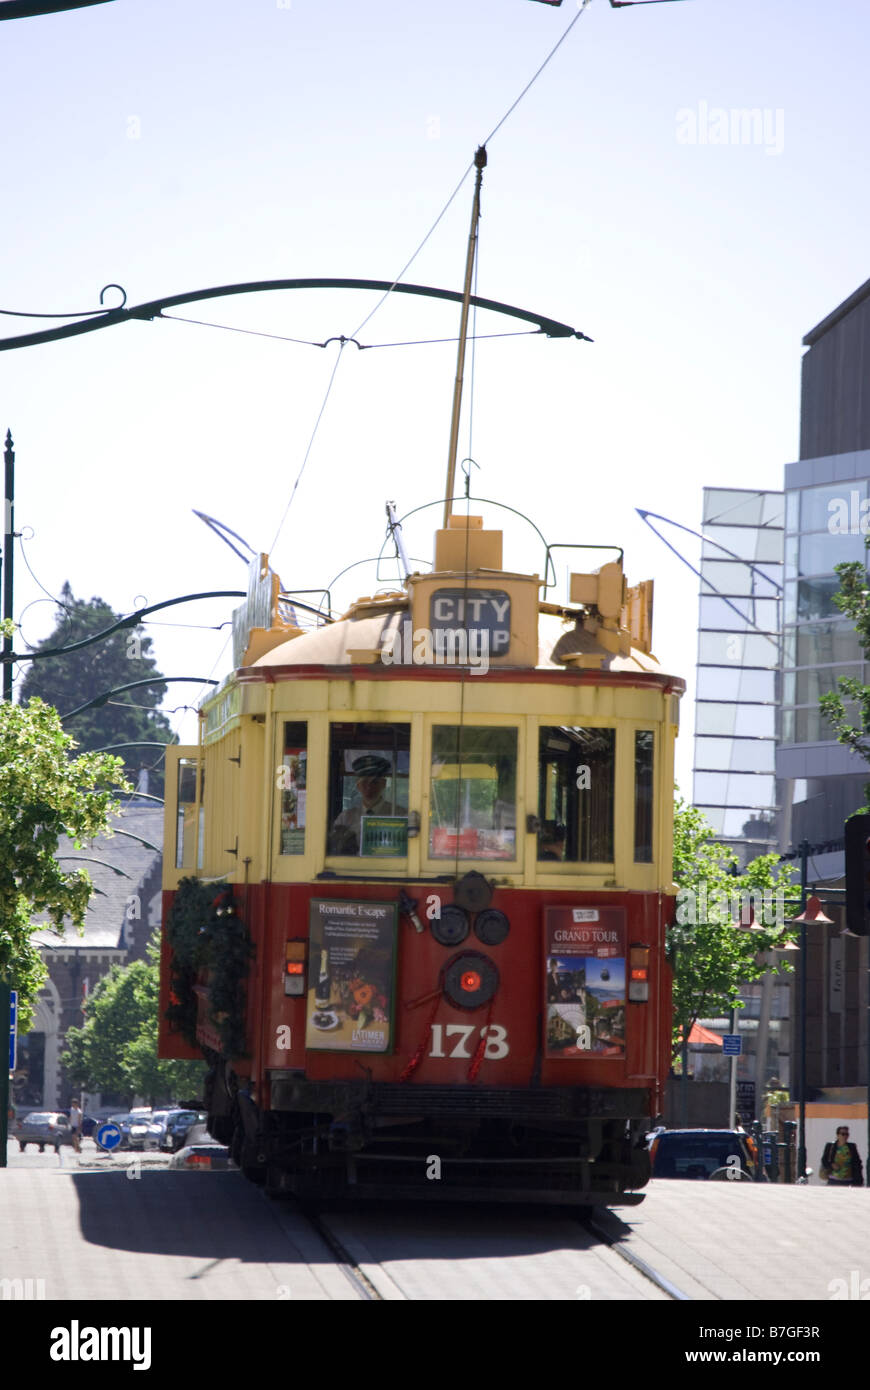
[208,1065,649,1207]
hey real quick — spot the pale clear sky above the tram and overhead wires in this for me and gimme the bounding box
[0,0,870,794]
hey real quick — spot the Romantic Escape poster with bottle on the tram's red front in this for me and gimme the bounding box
[306,898,396,1052]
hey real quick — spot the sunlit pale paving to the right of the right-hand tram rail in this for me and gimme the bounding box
[600,1179,870,1302]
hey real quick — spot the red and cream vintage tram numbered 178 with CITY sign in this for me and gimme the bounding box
[160,506,684,1207]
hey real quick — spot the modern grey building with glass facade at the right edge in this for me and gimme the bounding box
[683,281,870,1098]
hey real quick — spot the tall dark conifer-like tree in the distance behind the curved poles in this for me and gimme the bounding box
[18,582,172,796]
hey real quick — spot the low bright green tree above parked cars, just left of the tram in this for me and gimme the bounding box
[61,934,204,1105]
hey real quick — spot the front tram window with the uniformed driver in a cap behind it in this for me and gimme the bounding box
[327,723,411,858]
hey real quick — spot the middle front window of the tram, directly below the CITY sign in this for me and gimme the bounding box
[429,724,517,859]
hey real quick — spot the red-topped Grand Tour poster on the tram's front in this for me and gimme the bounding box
[543,908,625,1058]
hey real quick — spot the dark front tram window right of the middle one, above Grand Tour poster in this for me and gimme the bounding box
[538,726,616,863]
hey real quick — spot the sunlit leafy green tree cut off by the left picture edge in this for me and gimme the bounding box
[0,699,129,1033]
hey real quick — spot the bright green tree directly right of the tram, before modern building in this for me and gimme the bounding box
[667,798,801,1052]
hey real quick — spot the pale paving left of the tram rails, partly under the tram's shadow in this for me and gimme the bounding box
[0,1169,357,1302]
